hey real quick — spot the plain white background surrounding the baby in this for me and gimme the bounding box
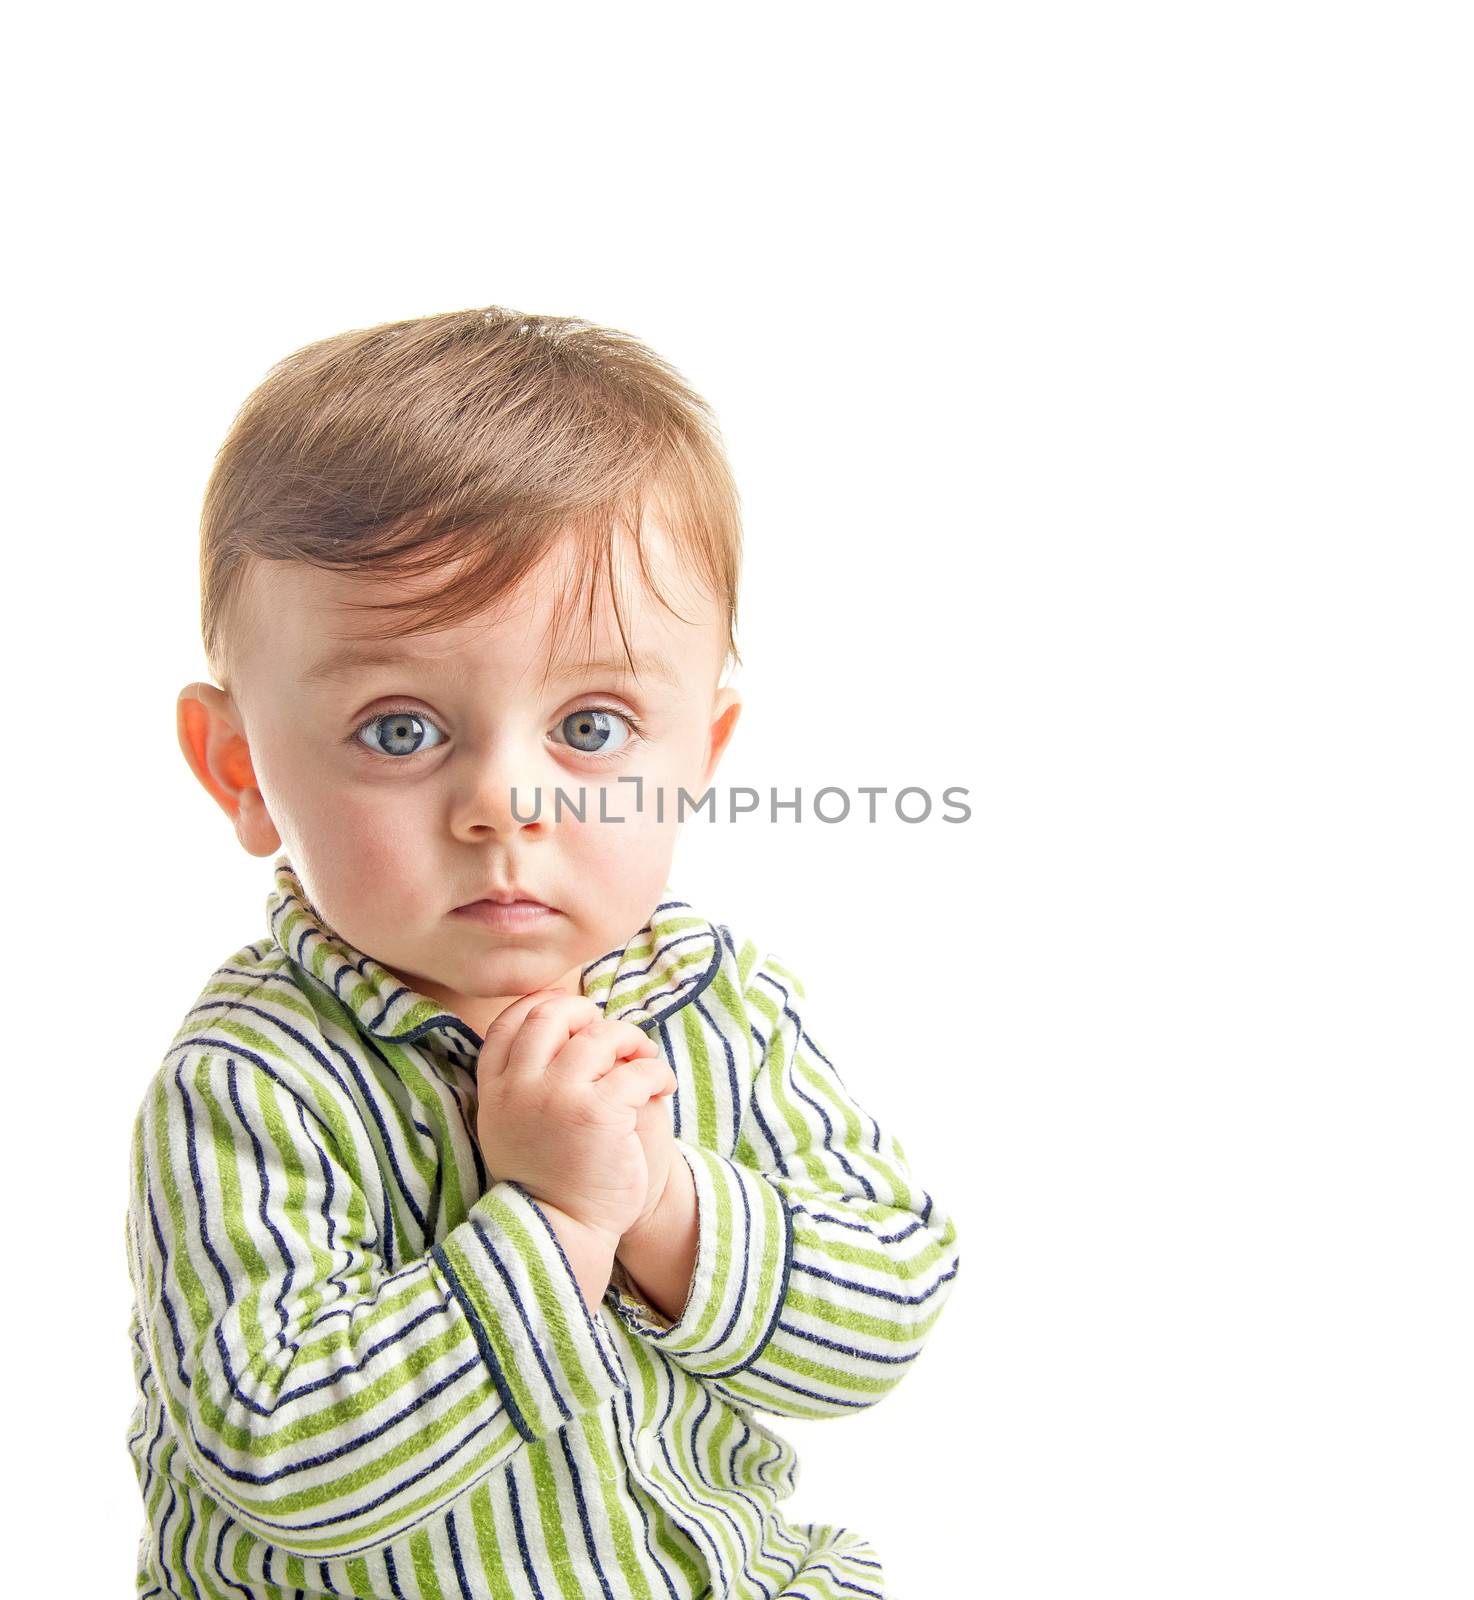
[3,0,1474,1600]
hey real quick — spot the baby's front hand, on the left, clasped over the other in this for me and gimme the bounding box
[475,989,675,1242]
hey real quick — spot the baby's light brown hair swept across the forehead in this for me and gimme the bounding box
[200,306,741,690]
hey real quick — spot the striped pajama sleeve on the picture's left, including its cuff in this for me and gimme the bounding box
[128,1045,627,1557]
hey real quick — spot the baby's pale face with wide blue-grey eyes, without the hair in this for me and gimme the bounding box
[216,518,739,1032]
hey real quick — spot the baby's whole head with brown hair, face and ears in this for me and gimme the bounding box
[178,307,741,1030]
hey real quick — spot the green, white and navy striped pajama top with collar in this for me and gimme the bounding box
[126,856,959,1600]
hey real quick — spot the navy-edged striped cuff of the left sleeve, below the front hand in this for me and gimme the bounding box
[431,1179,629,1440]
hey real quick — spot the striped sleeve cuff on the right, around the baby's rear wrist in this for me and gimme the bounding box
[607,1139,794,1378]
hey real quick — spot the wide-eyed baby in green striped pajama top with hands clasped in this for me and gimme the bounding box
[128,307,959,1600]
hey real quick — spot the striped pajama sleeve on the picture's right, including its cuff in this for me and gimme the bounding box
[613,955,960,1418]
